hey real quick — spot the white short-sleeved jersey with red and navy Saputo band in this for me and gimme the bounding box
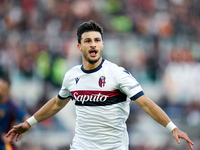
[58,59,144,150]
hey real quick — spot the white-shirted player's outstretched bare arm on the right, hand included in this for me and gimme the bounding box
[135,95,194,149]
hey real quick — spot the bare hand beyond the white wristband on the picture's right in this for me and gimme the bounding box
[172,128,194,149]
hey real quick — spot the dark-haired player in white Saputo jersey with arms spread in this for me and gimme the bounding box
[7,21,194,150]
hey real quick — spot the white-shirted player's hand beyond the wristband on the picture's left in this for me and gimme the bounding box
[6,121,31,143]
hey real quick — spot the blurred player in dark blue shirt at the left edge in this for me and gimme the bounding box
[0,77,29,150]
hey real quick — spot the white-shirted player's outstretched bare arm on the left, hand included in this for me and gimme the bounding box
[6,96,71,142]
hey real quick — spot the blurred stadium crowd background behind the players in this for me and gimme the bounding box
[0,0,200,150]
